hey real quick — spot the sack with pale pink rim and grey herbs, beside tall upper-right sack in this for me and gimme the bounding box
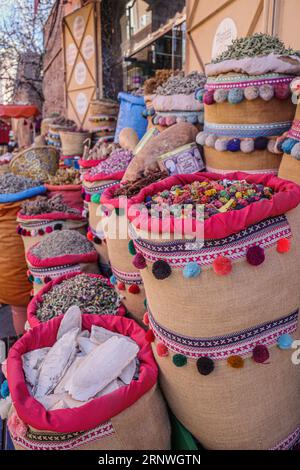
[152,72,206,128]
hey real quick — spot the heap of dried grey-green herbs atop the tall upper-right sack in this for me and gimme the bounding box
[212,33,300,64]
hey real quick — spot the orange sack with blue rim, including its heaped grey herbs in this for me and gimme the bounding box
[0,173,46,334]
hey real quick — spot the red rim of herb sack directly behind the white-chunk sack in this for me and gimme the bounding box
[27,271,126,328]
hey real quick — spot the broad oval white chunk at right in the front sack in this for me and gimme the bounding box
[69,336,139,401]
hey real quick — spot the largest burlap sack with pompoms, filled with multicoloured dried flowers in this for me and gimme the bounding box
[128,173,300,449]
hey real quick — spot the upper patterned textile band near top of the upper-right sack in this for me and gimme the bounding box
[205,74,294,91]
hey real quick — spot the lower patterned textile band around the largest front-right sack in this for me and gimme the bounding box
[148,308,299,360]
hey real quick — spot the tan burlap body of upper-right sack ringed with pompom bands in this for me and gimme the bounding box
[200,73,295,174]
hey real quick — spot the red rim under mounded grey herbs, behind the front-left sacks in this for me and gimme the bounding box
[26,246,98,268]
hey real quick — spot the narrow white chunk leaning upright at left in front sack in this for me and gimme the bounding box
[34,328,79,397]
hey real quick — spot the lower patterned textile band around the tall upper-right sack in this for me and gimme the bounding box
[204,121,292,139]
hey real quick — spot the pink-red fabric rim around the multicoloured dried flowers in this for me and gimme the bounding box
[101,172,300,240]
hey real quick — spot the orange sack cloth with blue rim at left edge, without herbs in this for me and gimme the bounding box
[0,186,45,306]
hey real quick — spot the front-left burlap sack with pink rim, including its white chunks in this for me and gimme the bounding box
[7,315,170,450]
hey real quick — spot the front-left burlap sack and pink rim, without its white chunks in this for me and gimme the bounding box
[7,315,170,450]
